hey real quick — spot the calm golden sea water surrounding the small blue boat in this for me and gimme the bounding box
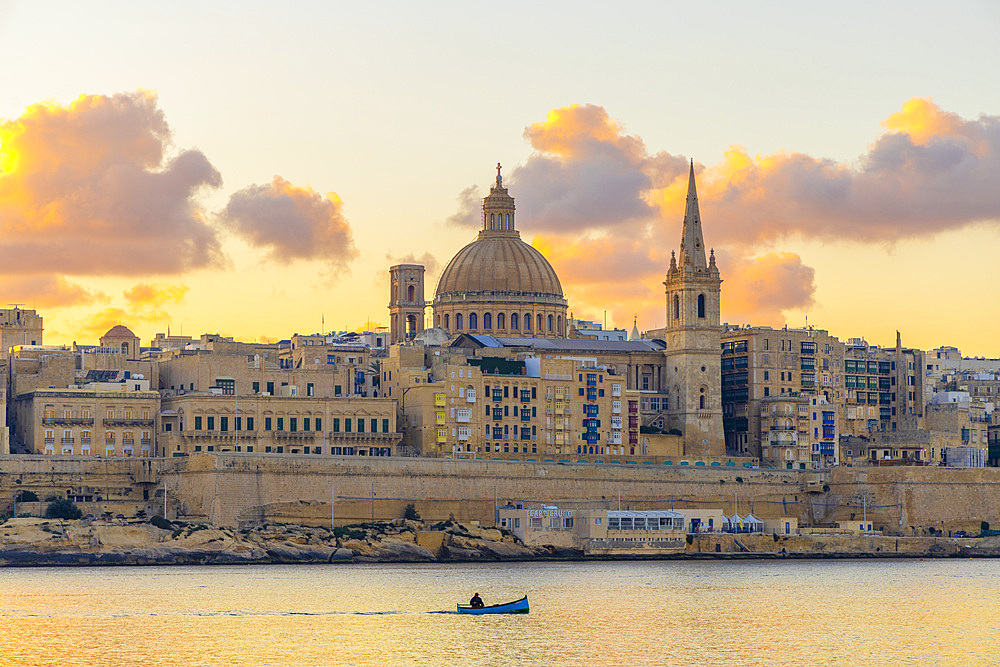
[0,560,1000,665]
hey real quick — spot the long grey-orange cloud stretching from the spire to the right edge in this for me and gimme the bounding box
[652,99,1000,246]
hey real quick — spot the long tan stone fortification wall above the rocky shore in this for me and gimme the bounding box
[0,453,1000,535]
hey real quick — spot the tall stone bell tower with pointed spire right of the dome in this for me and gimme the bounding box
[663,160,725,456]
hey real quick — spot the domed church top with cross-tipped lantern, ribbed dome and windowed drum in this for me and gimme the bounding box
[432,164,567,340]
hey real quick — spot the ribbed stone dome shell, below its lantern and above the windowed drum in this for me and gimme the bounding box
[437,231,563,299]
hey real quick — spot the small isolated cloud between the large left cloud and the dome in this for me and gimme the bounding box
[221,176,358,269]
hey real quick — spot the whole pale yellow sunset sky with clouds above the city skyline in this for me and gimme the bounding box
[0,0,1000,357]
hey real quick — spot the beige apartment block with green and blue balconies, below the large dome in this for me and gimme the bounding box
[397,357,655,462]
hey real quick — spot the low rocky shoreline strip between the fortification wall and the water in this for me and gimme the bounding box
[0,518,1000,567]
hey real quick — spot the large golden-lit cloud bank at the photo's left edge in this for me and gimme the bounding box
[0,91,225,276]
